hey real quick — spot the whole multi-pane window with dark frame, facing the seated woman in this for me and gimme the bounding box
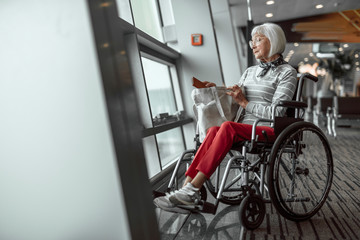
[117,0,192,178]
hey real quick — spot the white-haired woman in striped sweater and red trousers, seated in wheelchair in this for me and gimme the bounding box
[154,23,297,212]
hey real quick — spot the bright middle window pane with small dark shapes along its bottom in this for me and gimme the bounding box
[141,57,177,125]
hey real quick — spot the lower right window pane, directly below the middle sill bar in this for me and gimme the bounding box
[156,128,185,169]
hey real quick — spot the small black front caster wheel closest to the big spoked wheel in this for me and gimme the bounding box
[239,194,266,230]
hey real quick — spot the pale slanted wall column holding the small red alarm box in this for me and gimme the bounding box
[172,0,224,147]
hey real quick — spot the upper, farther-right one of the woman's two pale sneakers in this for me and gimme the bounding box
[168,183,200,205]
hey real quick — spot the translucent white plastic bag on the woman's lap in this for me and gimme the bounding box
[191,87,243,142]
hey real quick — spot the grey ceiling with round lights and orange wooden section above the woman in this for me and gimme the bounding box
[229,0,360,69]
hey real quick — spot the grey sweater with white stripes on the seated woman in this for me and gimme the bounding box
[238,64,297,125]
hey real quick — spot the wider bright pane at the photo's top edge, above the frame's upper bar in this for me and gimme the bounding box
[131,0,163,42]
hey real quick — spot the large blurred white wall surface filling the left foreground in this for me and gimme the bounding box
[0,0,129,240]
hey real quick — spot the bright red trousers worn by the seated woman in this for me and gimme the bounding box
[185,122,275,179]
